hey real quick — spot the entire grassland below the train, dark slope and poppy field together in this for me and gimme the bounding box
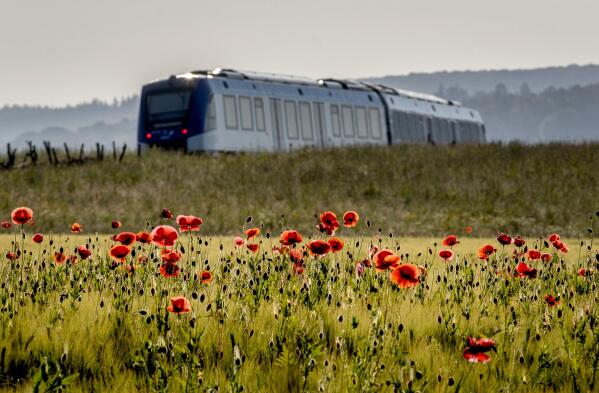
[0,145,599,392]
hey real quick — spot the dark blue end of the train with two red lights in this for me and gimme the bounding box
[137,74,210,151]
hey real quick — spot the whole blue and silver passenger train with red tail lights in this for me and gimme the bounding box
[138,69,485,152]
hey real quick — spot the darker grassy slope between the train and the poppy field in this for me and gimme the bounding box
[0,144,599,237]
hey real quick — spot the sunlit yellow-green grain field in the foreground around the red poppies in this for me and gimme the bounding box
[0,222,599,392]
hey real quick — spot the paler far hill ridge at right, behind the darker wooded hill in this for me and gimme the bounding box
[363,64,599,94]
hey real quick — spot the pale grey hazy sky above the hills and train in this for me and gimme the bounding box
[0,0,599,105]
